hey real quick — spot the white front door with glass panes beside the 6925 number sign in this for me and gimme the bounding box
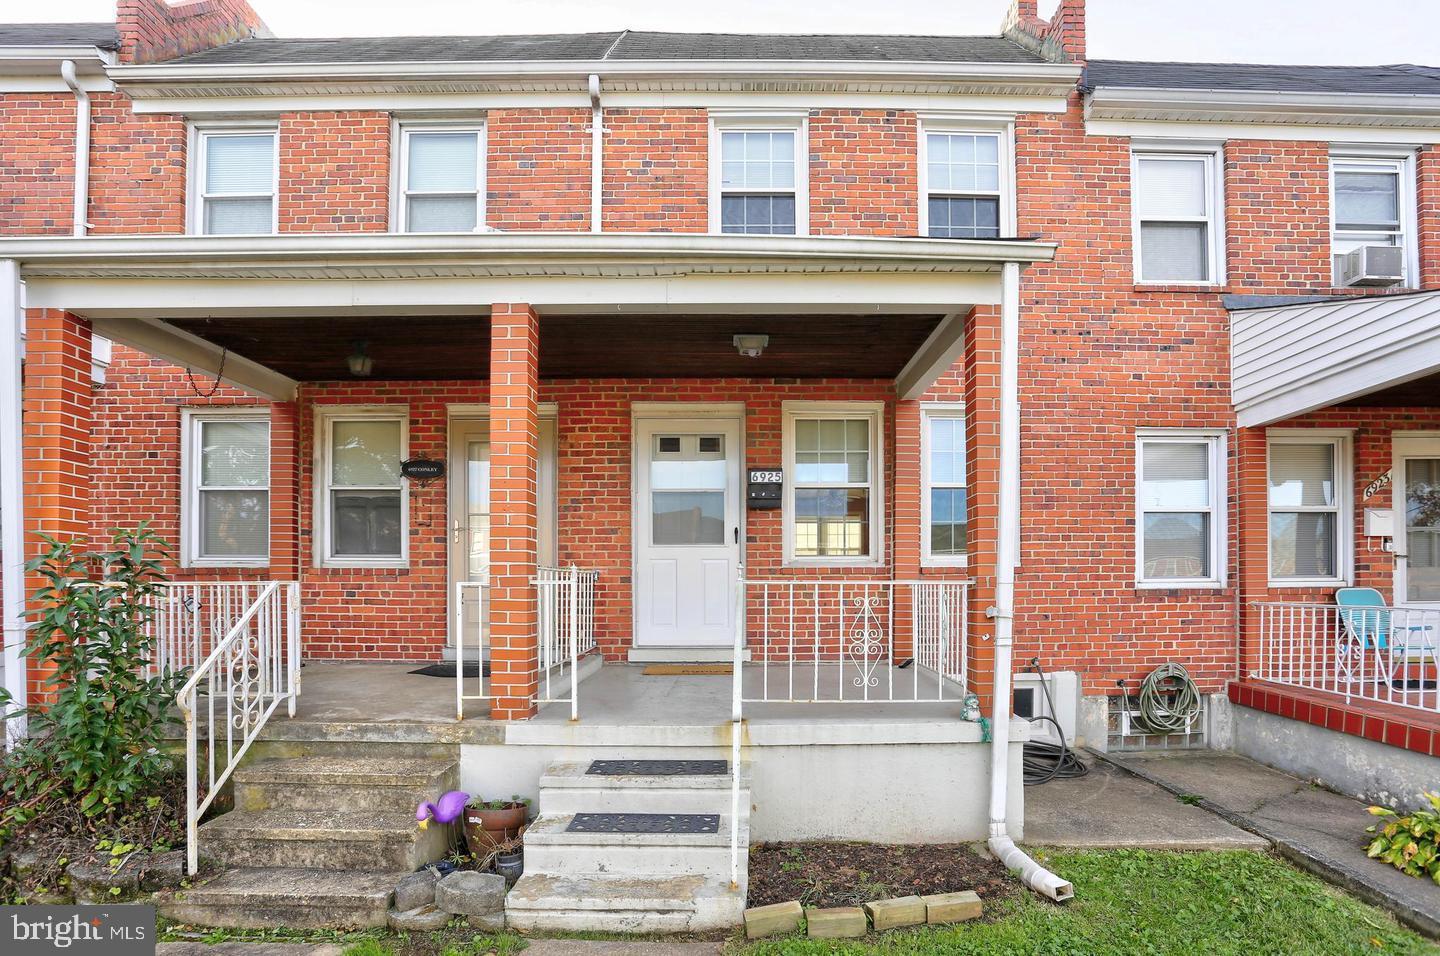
[635,418,742,646]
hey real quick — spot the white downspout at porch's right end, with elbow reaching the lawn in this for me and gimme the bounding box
[988,262,1074,901]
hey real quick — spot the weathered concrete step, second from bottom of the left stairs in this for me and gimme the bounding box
[200,798,454,872]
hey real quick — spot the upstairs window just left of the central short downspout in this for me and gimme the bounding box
[399,127,485,232]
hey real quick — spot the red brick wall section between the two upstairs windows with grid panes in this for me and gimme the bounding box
[809,109,920,236]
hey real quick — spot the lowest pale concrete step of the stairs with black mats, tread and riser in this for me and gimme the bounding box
[505,872,744,933]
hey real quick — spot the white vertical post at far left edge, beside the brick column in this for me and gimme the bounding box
[0,259,26,743]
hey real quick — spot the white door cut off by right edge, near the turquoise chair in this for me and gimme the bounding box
[1391,432,1440,605]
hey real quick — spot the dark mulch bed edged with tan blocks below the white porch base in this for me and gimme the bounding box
[749,844,1020,907]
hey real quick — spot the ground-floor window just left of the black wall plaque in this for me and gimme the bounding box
[315,407,408,567]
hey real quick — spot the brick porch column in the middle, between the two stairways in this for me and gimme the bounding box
[490,302,540,720]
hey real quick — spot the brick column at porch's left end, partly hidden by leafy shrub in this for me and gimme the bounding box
[24,310,92,701]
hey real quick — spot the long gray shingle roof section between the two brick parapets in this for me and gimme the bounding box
[168,30,1043,65]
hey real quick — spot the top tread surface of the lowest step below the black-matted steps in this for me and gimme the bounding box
[505,872,743,913]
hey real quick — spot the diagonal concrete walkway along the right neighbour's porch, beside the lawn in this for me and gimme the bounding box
[1100,750,1440,937]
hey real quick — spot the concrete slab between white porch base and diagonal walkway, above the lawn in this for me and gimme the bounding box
[1022,760,1270,849]
